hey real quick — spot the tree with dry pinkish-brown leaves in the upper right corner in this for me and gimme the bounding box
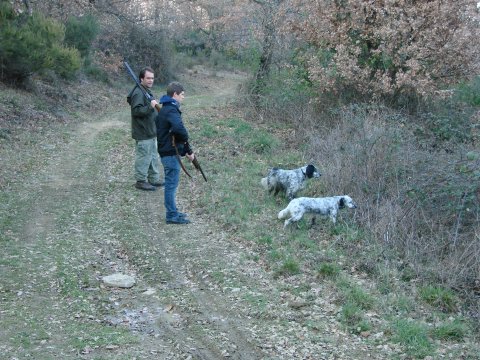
[292,0,480,99]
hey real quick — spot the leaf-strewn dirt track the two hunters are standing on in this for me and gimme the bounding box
[0,69,402,359]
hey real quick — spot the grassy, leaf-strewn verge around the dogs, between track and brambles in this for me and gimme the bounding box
[188,101,475,358]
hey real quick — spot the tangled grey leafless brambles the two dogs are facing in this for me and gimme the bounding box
[298,105,480,290]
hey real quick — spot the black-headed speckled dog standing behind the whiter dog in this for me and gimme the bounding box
[261,164,321,200]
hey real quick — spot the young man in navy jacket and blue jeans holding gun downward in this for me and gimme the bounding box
[156,82,195,224]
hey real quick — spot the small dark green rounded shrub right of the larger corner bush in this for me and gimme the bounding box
[65,14,100,58]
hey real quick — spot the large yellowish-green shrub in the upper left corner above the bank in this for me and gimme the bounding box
[0,2,80,82]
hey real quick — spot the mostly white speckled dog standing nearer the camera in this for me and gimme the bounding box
[278,195,357,227]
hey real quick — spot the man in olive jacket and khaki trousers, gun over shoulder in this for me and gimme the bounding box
[127,67,163,191]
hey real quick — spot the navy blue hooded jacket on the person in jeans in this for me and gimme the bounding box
[155,95,192,157]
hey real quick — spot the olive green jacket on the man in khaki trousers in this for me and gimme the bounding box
[127,86,157,140]
